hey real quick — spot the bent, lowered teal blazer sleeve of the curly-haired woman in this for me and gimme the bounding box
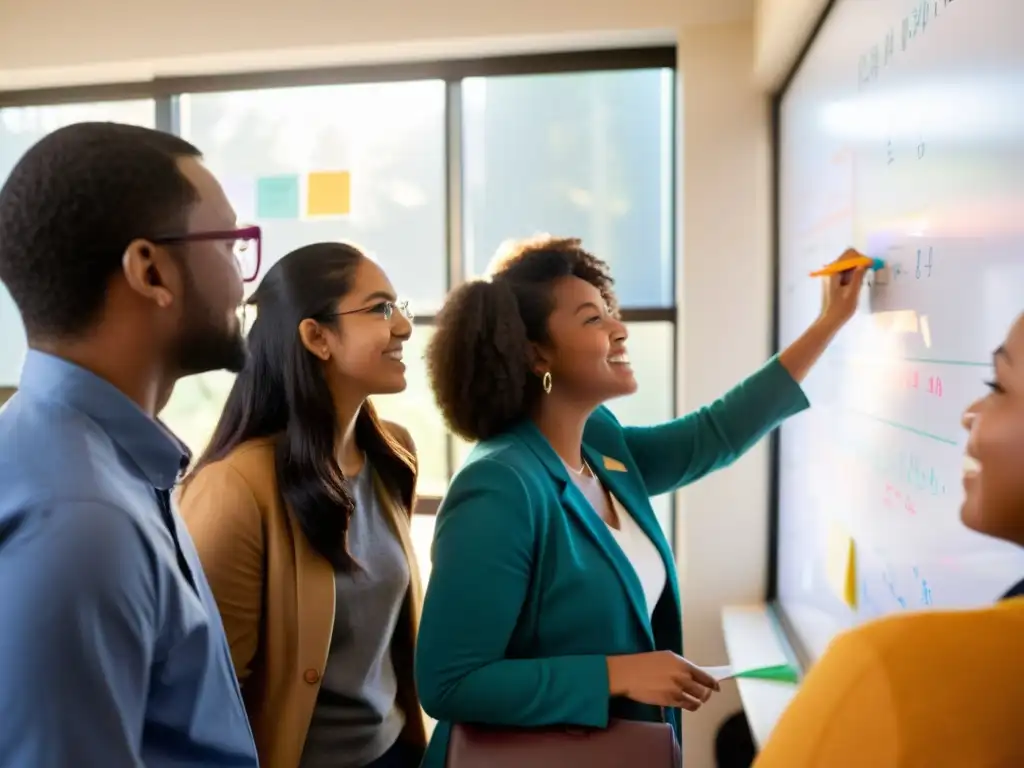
[416,459,609,727]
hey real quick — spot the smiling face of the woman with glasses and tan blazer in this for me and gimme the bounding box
[299,258,413,398]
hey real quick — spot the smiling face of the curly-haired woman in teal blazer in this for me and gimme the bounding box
[535,278,637,406]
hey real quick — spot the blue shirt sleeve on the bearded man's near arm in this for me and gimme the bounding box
[0,503,160,768]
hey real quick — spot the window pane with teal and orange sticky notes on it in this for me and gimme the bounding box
[179,81,447,314]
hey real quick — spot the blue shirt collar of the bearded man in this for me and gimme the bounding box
[19,349,191,490]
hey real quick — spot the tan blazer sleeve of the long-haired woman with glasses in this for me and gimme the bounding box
[178,462,263,685]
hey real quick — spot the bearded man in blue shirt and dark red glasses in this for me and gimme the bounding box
[0,123,259,768]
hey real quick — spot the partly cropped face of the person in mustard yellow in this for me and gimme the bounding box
[961,315,1024,546]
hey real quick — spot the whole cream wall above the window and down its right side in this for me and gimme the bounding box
[0,0,821,768]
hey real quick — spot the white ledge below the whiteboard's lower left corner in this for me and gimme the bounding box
[722,604,798,750]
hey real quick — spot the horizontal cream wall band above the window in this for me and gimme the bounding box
[0,0,754,89]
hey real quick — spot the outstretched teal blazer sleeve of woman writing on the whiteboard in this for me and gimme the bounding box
[623,357,808,496]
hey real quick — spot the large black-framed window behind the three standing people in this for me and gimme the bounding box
[0,50,676,565]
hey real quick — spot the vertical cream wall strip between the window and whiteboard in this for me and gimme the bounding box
[677,24,771,768]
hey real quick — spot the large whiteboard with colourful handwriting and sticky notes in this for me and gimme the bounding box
[776,0,1024,660]
